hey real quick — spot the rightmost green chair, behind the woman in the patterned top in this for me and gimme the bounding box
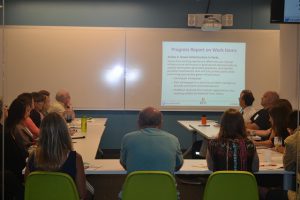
[203,171,259,200]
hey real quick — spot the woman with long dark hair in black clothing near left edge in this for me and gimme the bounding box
[1,98,33,199]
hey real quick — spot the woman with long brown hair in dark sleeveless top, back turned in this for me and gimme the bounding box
[25,112,87,199]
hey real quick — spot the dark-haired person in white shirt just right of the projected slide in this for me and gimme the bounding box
[239,90,256,123]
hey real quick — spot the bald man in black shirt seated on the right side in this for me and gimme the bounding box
[246,91,279,130]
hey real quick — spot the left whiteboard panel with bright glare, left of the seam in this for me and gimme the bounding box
[5,27,125,109]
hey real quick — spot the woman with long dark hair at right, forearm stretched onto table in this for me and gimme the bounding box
[254,104,291,148]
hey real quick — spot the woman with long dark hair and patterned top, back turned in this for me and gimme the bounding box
[206,109,259,172]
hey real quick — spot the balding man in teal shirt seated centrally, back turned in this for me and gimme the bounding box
[120,107,183,173]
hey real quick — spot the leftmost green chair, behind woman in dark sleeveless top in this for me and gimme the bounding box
[25,171,79,200]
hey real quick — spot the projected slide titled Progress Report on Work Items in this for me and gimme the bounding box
[161,42,246,107]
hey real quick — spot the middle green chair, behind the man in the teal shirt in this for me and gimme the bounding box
[122,171,177,200]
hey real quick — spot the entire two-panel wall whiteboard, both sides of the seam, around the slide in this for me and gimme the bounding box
[4,26,280,110]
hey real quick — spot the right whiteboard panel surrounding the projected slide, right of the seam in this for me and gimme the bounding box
[125,29,280,110]
